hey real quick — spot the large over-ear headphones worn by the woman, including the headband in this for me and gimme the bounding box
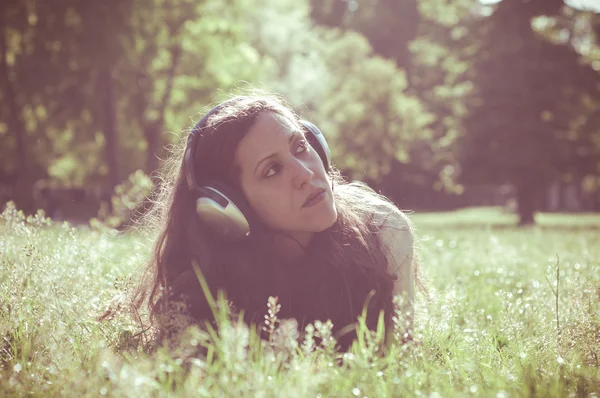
[183,98,331,241]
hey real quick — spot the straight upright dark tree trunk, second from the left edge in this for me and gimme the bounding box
[99,66,120,192]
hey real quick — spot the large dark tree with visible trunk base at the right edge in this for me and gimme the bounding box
[457,0,600,224]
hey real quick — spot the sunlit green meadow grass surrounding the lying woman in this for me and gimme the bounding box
[0,207,600,397]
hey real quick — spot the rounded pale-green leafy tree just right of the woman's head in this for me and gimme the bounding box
[315,30,433,183]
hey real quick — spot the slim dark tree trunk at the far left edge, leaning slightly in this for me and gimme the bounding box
[0,13,34,211]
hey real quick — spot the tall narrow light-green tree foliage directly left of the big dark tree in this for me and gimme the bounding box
[401,0,482,194]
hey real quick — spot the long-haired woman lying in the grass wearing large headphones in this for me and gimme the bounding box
[135,96,419,349]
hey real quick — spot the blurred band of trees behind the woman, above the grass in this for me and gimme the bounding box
[0,0,600,224]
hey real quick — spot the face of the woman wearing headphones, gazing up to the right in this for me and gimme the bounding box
[235,112,337,244]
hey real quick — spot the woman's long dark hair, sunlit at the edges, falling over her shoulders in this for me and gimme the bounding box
[133,96,418,348]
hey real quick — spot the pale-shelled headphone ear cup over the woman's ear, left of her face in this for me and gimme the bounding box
[195,181,258,241]
